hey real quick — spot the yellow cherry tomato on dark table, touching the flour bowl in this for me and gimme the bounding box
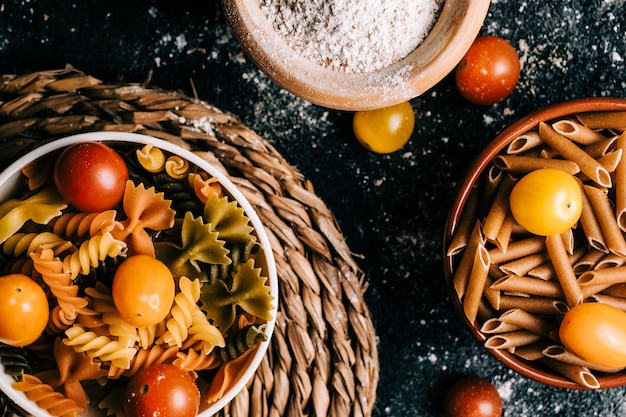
[352,102,415,154]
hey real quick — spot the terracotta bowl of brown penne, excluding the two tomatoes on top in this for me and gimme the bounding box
[443,98,626,389]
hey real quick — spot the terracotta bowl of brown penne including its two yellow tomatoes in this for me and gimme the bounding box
[443,98,626,390]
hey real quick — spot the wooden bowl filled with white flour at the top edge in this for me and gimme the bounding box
[222,0,490,111]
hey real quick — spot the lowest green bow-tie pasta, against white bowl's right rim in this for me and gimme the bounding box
[200,259,273,332]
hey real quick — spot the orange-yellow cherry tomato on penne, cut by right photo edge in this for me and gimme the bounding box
[559,303,626,368]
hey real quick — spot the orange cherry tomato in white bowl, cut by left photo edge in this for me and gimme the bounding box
[0,274,50,347]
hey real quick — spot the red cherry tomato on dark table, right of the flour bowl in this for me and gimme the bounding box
[455,36,520,105]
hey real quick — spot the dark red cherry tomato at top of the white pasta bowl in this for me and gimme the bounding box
[54,142,128,212]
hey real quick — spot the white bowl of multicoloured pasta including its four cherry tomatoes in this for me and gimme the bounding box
[0,132,278,417]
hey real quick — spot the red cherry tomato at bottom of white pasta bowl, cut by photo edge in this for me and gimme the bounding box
[124,364,200,417]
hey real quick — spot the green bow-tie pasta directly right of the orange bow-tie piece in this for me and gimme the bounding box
[155,212,231,278]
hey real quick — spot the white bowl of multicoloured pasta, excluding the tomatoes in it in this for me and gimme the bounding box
[0,132,278,417]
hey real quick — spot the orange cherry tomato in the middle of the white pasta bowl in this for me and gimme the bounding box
[111,255,176,327]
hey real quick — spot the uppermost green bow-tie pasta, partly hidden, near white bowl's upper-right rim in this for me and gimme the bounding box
[204,194,256,242]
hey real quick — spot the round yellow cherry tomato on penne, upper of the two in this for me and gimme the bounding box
[509,168,583,236]
